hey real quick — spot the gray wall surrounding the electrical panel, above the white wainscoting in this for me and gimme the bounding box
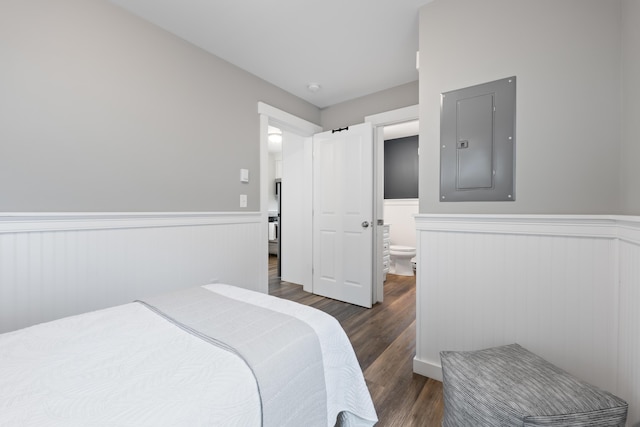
[420,0,624,214]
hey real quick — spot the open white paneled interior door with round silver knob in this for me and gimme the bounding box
[313,123,375,307]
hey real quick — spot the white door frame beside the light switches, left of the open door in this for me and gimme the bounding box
[258,102,322,293]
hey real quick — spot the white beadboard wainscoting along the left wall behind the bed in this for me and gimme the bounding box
[0,213,268,333]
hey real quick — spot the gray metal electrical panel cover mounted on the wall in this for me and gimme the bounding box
[440,77,516,202]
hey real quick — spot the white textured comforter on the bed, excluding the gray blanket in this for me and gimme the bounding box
[0,284,376,427]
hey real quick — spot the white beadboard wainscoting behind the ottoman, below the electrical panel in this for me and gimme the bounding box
[414,215,640,425]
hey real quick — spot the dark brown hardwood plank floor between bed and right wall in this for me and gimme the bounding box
[269,256,443,427]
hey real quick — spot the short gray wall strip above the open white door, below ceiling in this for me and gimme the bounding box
[320,81,418,130]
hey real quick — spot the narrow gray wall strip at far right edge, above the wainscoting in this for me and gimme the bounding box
[621,0,640,215]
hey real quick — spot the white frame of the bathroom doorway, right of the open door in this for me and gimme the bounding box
[364,105,420,303]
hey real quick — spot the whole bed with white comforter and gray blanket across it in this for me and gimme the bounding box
[0,284,377,427]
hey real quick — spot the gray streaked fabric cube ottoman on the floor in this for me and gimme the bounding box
[440,344,627,427]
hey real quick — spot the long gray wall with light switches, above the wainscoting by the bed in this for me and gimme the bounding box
[0,0,320,212]
